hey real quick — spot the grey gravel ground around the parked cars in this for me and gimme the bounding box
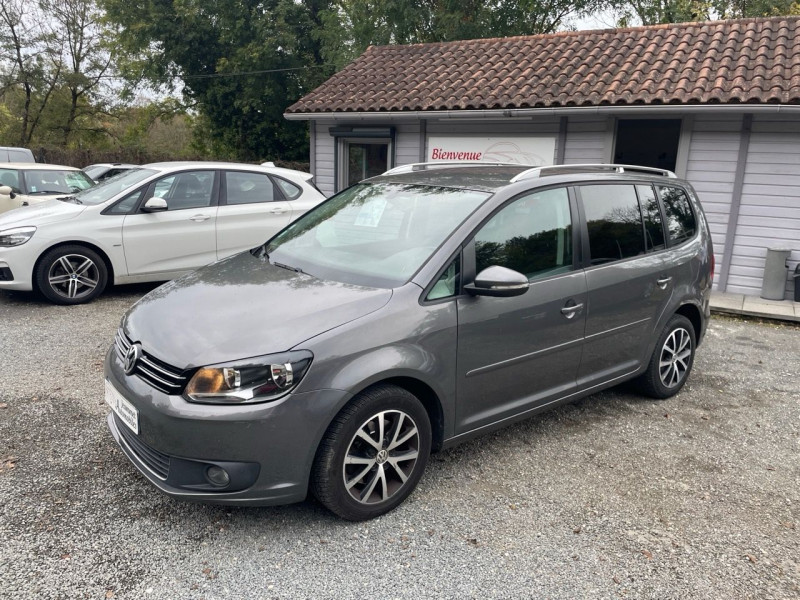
[0,286,800,600]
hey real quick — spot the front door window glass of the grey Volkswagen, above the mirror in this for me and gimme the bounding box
[475,188,572,279]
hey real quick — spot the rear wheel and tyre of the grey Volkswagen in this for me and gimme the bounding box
[638,315,696,400]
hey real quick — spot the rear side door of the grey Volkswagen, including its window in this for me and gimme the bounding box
[576,183,674,388]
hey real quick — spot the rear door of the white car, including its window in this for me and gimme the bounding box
[217,171,292,258]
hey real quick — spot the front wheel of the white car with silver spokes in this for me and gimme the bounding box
[36,246,108,304]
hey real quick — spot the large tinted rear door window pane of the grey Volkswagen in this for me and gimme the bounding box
[579,185,645,265]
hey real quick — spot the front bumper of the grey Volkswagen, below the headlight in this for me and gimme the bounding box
[105,347,350,505]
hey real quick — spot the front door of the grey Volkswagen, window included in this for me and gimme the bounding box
[456,188,586,433]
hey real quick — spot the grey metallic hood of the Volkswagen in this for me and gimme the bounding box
[123,252,392,369]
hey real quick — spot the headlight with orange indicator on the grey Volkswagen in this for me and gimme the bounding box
[185,350,314,404]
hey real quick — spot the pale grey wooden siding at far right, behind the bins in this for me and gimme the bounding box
[727,115,800,298]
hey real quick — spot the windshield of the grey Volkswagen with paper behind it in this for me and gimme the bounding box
[266,183,490,288]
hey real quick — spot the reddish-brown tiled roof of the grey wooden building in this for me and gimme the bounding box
[286,17,800,113]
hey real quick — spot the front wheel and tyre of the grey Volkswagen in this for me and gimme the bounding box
[311,385,431,521]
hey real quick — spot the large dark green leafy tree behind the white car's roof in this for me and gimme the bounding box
[104,0,334,160]
